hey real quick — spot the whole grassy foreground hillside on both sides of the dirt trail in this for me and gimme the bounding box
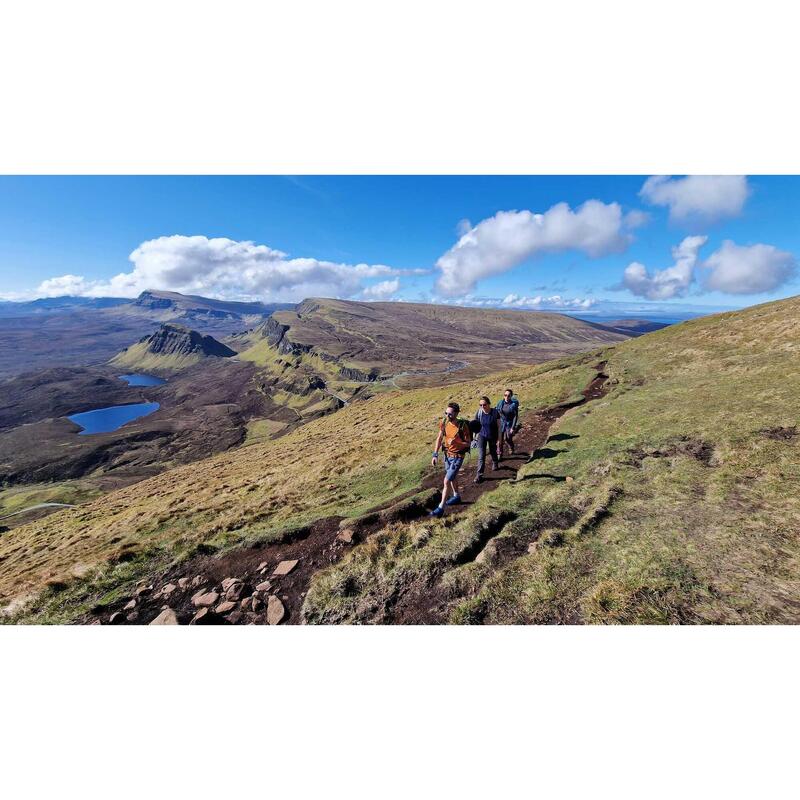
[6,298,800,623]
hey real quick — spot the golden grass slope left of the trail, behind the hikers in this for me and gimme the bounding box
[0,355,597,621]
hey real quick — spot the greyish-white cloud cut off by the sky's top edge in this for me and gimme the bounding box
[639,175,750,222]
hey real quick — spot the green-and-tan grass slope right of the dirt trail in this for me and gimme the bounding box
[305,298,800,623]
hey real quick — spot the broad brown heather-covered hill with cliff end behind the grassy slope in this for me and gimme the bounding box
[238,298,629,388]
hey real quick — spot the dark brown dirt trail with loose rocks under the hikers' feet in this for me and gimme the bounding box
[89,362,608,625]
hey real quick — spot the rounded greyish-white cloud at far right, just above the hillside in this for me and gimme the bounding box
[702,240,797,294]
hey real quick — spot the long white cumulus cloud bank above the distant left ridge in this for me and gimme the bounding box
[28,236,410,302]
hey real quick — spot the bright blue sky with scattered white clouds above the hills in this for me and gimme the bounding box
[0,176,800,313]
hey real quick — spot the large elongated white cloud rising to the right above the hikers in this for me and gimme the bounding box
[436,200,630,297]
